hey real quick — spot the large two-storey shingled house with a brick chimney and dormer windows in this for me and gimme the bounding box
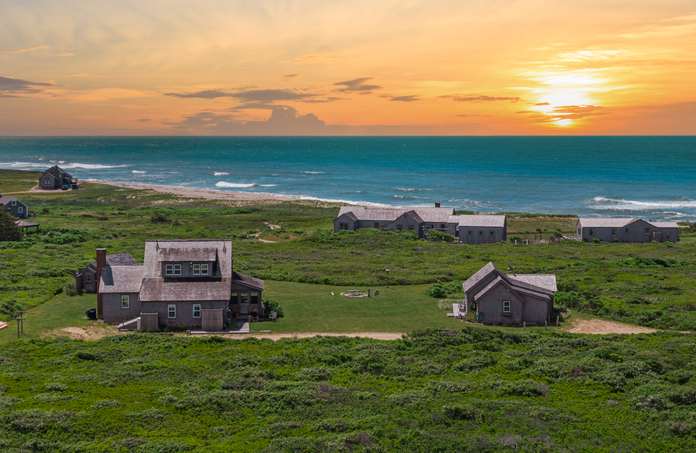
[97,240,264,330]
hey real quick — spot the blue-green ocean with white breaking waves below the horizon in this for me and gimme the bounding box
[0,137,696,221]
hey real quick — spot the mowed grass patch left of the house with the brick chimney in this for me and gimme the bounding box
[0,294,103,343]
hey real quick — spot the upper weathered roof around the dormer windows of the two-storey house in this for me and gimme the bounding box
[143,239,232,278]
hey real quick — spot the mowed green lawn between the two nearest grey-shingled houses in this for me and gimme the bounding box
[264,281,463,333]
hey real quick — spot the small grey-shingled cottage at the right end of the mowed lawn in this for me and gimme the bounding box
[462,263,557,324]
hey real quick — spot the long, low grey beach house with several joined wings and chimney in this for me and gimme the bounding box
[334,203,507,244]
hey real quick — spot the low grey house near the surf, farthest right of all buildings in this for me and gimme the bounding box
[577,218,679,242]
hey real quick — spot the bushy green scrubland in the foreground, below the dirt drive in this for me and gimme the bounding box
[0,328,696,453]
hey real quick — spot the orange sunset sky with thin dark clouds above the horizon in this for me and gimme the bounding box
[0,0,696,136]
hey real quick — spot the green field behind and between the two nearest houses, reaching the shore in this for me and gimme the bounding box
[0,171,696,332]
